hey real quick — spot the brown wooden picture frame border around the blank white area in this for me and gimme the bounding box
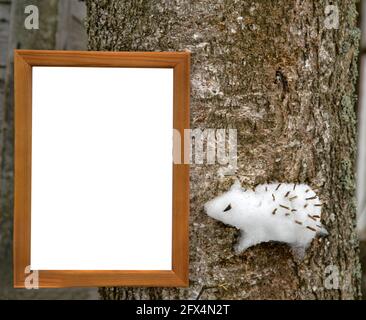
[14,50,190,288]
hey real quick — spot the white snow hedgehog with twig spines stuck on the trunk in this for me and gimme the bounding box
[204,181,328,259]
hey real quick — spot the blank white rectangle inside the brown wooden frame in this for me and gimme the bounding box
[31,66,173,270]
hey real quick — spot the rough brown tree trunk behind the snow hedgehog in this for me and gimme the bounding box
[87,0,361,299]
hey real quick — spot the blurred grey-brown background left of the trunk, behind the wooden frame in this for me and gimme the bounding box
[0,0,97,299]
